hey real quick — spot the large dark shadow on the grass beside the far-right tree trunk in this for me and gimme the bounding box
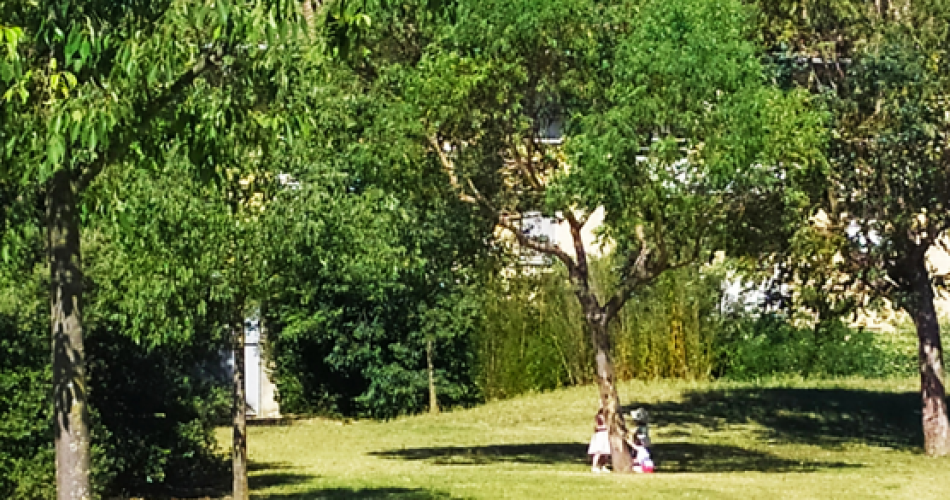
[626,389,923,449]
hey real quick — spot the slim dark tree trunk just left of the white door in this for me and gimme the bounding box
[231,302,248,500]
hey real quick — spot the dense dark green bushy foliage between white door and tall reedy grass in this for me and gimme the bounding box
[265,176,488,417]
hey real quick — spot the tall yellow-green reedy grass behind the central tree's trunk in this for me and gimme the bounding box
[477,259,721,399]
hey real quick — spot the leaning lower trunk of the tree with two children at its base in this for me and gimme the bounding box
[587,312,633,472]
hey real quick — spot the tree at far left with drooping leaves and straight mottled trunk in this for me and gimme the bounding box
[0,0,295,499]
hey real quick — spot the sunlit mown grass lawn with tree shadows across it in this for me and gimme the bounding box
[229,379,950,500]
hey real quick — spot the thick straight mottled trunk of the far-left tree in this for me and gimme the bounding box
[46,169,92,500]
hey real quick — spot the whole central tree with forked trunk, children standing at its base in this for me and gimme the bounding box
[346,0,822,471]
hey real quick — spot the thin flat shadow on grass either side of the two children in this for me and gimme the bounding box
[372,443,852,472]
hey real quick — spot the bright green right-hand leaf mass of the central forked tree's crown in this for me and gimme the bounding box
[564,1,824,268]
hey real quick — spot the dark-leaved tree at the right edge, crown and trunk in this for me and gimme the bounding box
[763,0,950,456]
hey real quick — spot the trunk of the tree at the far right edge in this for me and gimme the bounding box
[907,257,950,457]
